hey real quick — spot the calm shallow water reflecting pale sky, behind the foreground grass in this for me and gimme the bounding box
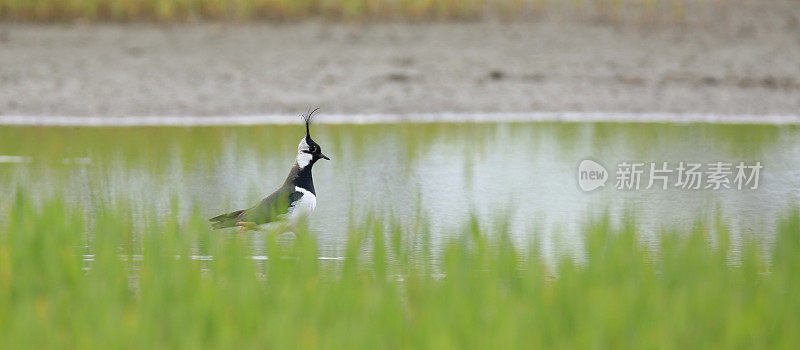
[0,123,800,258]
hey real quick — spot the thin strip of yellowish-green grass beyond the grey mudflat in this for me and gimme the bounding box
[0,0,707,22]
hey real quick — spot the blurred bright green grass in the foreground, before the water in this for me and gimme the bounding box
[0,191,800,349]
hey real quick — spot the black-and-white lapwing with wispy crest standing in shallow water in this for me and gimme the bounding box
[208,108,331,231]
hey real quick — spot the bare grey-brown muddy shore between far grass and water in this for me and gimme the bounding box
[0,6,800,117]
